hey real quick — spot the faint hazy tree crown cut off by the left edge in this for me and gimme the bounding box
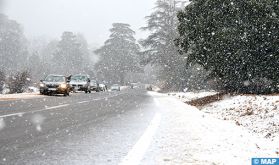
[0,13,28,72]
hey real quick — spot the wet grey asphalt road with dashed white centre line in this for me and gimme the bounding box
[0,89,156,165]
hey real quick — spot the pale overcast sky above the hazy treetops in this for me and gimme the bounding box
[0,0,156,46]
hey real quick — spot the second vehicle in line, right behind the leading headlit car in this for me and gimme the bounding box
[70,74,91,93]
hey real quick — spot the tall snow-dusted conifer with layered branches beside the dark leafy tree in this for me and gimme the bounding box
[141,0,189,89]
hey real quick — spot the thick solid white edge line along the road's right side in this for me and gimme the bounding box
[119,113,161,165]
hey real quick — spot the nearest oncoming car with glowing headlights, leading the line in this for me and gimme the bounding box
[39,74,71,96]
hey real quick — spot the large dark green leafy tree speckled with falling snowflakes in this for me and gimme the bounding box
[177,0,279,93]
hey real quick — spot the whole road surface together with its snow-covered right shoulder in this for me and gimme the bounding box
[0,89,278,165]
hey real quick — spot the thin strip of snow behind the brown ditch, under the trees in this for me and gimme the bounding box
[168,91,217,102]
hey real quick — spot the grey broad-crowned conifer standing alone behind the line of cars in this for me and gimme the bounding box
[95,23,140,84]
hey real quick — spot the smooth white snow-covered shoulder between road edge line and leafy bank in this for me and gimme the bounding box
[148,93,279,165]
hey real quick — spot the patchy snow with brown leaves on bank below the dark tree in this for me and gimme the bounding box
[201,95,279,144]
